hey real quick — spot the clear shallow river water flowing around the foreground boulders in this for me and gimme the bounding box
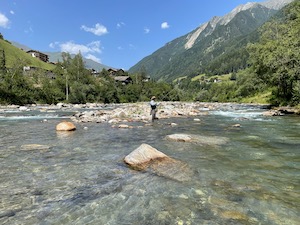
[0,107,300,225]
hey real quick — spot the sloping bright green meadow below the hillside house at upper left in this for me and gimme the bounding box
[0,39,55,70]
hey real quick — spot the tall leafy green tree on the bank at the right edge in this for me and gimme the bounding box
[249,1,300,105]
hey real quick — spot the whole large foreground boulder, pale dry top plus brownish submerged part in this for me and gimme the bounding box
[124,144,193,182]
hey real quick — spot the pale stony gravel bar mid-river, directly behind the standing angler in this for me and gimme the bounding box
[71,102,256,124]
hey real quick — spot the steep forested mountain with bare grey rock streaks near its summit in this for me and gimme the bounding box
[129,0,293,81]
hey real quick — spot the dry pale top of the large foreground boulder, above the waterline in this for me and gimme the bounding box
[124,144,168,168]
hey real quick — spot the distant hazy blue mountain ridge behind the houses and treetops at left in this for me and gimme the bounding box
[11,41,112,71]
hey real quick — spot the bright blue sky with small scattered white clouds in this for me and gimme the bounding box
[0,0,263,70]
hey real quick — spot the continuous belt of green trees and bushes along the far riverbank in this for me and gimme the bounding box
[0,1,300,105]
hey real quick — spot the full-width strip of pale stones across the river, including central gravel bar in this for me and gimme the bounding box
[0,102,300,124]
